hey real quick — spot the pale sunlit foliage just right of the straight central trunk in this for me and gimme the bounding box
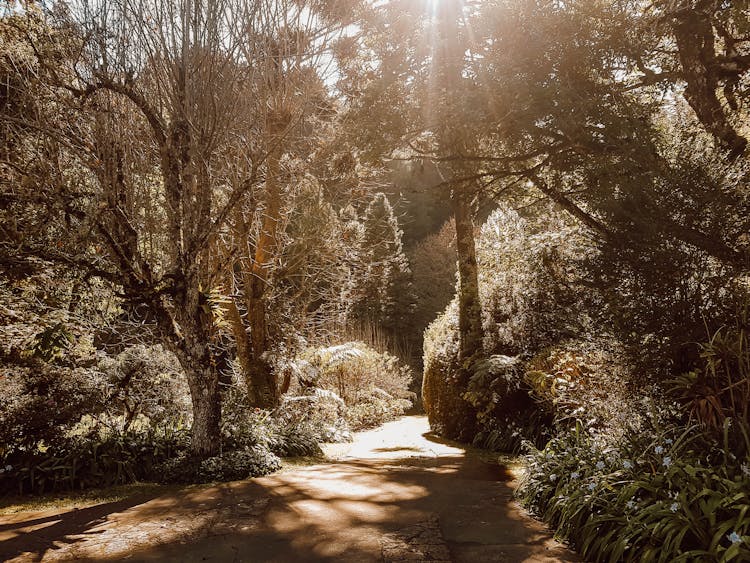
[477,208,595,355]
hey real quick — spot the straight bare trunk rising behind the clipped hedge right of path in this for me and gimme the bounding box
[452,190,482,360]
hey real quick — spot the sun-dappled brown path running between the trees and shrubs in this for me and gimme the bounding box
[0,417,578,563]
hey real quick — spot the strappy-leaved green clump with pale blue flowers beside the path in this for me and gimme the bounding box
[519,422,750,562]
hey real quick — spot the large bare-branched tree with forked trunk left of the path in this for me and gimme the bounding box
[2,0,262,456]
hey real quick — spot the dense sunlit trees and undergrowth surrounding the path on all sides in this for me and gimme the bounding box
[0,0,750,561]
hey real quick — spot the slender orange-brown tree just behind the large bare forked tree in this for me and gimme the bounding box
[222,0,368,408]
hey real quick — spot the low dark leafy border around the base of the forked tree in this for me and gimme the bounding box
[0,374,320,494]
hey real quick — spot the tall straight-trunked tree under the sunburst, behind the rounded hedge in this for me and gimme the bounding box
[340,0,490,360]
